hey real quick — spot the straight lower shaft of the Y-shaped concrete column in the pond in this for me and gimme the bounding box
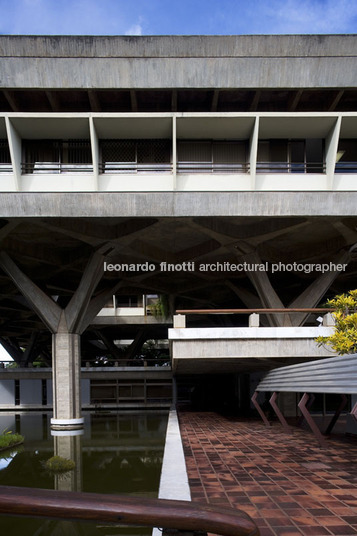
[51,332,84,430]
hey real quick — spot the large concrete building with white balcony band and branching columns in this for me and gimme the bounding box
[0,35,357,427]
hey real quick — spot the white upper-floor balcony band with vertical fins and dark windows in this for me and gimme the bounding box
[0,112,357,192]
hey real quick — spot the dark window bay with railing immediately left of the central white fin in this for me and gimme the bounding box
[99,139,171,173]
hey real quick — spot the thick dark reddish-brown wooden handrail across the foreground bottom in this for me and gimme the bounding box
[0,486,260,536]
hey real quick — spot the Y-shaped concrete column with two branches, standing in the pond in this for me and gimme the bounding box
[0,245,113,430]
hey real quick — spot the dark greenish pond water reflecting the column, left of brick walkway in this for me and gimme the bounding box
[0,413,167,536]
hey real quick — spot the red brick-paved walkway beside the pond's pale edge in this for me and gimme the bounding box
[179,411,357,536]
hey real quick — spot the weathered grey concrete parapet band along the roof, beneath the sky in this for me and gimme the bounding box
[0,35,357,89]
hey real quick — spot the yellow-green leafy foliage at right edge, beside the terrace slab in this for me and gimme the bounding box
[315,289,357,355]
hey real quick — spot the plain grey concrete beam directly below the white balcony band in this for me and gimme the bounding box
[0,191,357,220]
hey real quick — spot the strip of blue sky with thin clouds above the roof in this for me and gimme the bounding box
[0,0,357,35]
